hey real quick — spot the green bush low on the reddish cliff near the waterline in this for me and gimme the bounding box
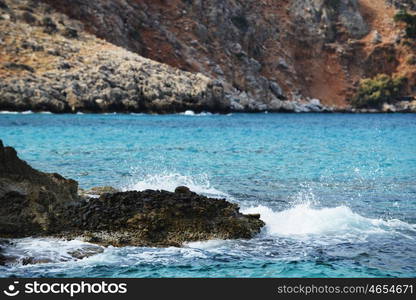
[350,74,406,108]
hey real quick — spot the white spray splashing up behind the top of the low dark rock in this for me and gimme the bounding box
[122,173,229,198]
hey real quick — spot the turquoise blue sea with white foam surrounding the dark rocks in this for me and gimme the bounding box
[0,112,416,277]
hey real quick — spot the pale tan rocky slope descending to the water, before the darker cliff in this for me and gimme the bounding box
[0,0,230,113]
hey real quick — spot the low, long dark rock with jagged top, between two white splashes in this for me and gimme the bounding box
[57,187,264,247]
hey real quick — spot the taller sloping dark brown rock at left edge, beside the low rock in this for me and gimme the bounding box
[0,140,78,237]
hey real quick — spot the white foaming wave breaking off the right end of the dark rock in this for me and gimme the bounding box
[244,202,416,238]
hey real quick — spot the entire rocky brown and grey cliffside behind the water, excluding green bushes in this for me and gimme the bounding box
[0,0,416,112]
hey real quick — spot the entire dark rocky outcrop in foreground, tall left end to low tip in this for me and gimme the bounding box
[0,142,264,247]
